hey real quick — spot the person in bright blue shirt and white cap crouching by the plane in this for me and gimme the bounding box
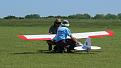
[53,20,78,53]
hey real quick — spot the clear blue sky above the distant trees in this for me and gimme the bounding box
[0,0,121,17]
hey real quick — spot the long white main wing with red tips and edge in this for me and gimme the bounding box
[19,31,113,41]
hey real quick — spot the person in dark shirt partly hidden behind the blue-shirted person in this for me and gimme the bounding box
[47,18,61,51]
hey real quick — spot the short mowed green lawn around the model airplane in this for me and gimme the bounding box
[0,26,121,68]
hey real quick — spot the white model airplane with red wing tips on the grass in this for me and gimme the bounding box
[18,30,114,52]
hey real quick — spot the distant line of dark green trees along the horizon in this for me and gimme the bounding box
[1,13,121,19]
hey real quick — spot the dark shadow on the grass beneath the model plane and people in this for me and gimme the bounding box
[12,50,102,55]
